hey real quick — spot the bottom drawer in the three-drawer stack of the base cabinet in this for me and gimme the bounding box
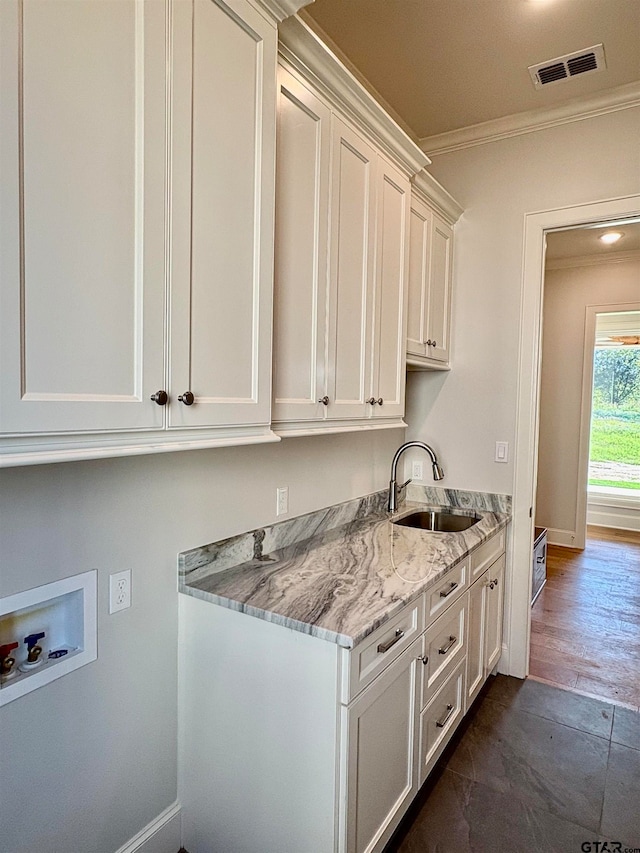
[418,658,465,785]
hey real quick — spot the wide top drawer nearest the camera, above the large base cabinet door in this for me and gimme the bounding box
[342,596,424,705]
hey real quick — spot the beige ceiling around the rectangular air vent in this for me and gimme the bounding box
[303,0,640,143]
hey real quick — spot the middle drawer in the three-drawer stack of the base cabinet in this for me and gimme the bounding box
[420,596,467,708]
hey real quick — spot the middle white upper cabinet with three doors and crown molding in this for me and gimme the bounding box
[273,18,427,435]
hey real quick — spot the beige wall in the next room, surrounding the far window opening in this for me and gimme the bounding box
[536,259,640,544]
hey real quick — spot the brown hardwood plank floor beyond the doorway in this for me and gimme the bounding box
[529,526,640,710]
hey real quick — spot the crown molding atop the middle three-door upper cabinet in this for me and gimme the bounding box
[278,15,431,176]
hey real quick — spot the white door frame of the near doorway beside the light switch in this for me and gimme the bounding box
[500,195,640,678]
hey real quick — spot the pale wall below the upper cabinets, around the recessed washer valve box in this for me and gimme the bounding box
[0,430,403,853]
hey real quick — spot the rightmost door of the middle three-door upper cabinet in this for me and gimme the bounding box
[370,156,411,418]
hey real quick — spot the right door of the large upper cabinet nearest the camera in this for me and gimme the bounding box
[169,0,277,427]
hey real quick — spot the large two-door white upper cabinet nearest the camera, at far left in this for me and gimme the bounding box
[0,0,310,465]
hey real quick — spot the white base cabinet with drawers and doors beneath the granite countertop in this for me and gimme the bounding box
[179,531,504,853]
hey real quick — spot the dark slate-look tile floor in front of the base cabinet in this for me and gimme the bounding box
[385,675,640,853]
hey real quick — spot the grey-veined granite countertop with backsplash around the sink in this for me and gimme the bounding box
[179,489,511,648]
